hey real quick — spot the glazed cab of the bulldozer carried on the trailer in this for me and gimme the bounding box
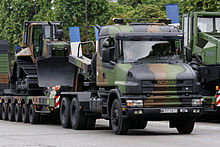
[22,21,63,60]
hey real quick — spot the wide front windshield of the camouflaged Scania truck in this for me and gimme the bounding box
[119,40,181,63]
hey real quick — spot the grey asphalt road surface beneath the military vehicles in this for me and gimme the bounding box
[0,120,220,147]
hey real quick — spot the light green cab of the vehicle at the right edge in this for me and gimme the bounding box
[182,12,220,64]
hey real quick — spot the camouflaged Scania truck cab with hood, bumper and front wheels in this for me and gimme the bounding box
[68,20,203,134]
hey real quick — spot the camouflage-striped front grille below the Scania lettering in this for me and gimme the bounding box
[142,80,193,107]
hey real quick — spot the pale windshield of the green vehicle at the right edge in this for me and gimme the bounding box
[198,17,220,33]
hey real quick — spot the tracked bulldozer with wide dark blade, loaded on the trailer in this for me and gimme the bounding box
[10,21,73,95]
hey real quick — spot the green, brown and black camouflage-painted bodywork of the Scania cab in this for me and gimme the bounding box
[96,24,199,107]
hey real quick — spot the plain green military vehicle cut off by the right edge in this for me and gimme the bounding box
[183,12,220,112]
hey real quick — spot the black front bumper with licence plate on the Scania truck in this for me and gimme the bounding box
[122,107,204,120]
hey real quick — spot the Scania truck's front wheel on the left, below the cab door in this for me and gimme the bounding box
[111,99,129,135]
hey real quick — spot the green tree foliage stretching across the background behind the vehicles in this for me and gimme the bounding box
[0,0,220,54]
